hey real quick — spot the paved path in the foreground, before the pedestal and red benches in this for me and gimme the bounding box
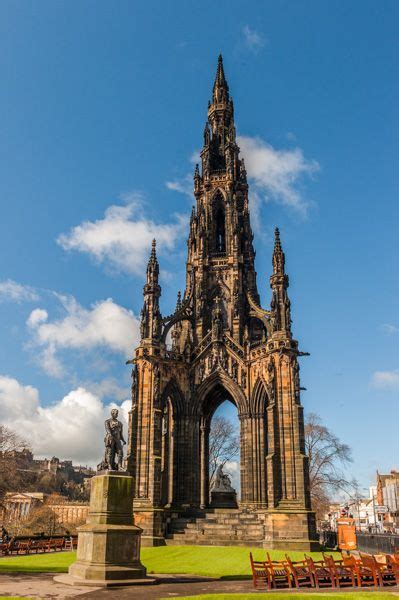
[0,573,399,600]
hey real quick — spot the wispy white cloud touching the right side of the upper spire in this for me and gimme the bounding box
[238,136,320,214]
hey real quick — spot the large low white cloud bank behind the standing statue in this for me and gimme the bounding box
[0,376,130,465]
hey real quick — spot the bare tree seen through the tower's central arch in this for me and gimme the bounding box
[209,416,240,487]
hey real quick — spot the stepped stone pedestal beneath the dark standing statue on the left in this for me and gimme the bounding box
[55,471,154,587]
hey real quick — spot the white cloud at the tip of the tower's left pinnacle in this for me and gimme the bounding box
[57,194,186,275]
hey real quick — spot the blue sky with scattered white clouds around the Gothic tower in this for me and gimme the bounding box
[0,0,399,486]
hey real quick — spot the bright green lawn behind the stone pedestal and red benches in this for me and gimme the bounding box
[0,546,338,579]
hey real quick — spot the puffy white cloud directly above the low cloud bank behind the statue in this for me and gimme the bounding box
[27,295,139,377]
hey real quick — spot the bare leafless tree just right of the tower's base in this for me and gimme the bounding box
[305,413,355,513]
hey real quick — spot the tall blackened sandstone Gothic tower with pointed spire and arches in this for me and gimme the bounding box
[128,57,315,550]
